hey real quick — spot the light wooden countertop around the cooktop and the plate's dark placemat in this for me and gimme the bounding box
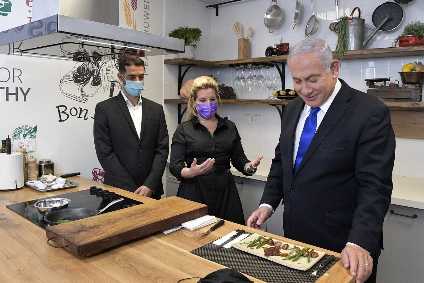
[0,177,351,283]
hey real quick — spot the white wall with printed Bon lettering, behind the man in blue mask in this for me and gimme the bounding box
[0,0,163,181]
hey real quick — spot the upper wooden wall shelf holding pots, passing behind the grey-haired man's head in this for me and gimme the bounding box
[165,46,424,68]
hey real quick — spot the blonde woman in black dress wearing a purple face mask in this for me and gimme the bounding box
[170,76,262,224]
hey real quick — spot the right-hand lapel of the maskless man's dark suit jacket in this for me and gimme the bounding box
[296,80,352,174]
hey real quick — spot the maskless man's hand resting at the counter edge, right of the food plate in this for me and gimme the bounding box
[342,244,373,283]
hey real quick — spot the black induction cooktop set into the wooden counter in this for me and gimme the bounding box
[7,187,142,229]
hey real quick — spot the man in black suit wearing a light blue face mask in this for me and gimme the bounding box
[94,50,169,199]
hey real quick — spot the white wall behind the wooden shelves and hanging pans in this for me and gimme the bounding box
[164,0,424,180]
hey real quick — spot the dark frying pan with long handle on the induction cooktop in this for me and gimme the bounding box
[44,198,124,225]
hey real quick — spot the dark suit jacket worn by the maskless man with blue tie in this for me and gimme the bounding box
[261,80,395,255]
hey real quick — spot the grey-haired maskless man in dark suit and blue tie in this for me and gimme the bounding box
[247,39,395,282]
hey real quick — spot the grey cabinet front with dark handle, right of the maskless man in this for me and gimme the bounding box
[377,205,424,283]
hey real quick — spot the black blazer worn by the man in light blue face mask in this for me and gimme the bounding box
[94,93,169,198]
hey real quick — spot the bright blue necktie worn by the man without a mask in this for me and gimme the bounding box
[294,107,320,172]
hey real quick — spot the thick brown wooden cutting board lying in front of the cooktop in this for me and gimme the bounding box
[46,197,207,257]
